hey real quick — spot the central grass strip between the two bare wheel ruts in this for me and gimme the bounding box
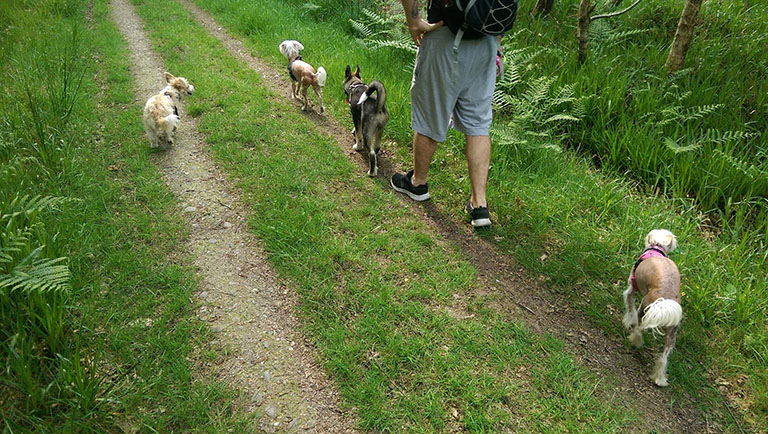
[126,1,664,432]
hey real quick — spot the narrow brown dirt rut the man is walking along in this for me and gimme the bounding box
[177,0,720,433]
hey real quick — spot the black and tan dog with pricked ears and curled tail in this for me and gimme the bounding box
[343,65,389,177]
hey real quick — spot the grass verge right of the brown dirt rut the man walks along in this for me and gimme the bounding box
[188,0,768,431]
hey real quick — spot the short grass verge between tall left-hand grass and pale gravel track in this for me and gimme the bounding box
[82,0,254,432]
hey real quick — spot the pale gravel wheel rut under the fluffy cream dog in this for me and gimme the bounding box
[112,0,355,433]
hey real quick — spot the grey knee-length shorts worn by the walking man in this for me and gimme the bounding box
[411,27,498,142]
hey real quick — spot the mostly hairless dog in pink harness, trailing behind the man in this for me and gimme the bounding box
[623,229,683,387]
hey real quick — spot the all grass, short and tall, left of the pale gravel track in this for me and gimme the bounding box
[0,1,250,432]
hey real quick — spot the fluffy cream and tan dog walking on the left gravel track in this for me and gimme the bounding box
[144,72,195,150]
